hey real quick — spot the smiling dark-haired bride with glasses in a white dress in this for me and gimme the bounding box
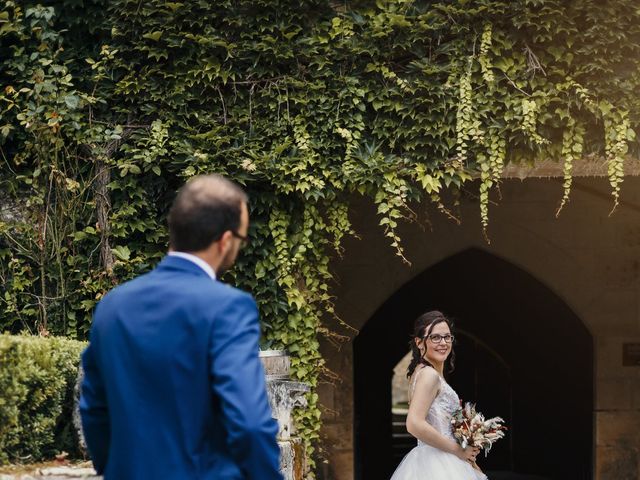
[391,311,487,480]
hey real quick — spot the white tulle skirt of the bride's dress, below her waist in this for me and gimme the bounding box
[391,444,487,480]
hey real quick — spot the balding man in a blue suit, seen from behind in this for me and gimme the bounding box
[80,175,282,480]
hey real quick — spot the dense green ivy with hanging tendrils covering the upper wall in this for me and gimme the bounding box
[0,0,640,472]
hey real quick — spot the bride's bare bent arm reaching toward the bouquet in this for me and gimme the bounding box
[407,367,478,461]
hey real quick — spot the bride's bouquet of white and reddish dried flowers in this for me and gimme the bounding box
[451,402,507,456]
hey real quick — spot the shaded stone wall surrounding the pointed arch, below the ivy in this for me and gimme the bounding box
[320,177,640,480]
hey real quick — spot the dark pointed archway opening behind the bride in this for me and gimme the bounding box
[354,249,594,480]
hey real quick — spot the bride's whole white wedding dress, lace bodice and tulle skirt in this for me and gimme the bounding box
[391,367,487,480]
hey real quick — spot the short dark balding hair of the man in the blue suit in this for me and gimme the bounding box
[169,175,248,252]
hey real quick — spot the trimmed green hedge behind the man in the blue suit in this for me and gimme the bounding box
[0,335,85,464]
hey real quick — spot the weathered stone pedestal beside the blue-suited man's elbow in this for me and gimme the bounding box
[260,350,309,480]
